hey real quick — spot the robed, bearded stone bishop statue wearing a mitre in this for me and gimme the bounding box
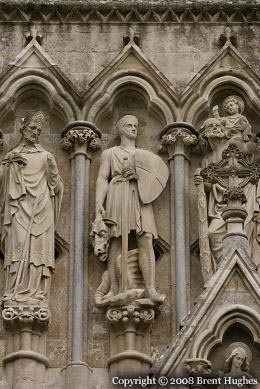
[0,112,63,304]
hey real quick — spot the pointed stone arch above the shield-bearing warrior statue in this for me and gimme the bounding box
[83,44,178,124]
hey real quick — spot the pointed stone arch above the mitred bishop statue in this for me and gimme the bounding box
[0,39,79,122]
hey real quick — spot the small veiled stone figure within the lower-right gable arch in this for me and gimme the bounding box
[218,342,257,389]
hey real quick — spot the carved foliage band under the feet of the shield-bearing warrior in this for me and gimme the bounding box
[106,305,155,326]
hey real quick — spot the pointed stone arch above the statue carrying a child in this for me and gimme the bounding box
[181,44,260,124]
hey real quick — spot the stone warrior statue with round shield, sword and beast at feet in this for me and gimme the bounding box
[92,115,169,305]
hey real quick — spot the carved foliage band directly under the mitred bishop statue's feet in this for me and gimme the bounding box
[2,305,50,328]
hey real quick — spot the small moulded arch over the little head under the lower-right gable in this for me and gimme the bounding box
[191,304,260,359]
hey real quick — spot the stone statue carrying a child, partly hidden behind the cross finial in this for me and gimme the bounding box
[195,95,260,272]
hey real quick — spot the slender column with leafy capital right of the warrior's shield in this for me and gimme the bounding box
[160,123,197,331]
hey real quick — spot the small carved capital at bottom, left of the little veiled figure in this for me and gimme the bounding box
[185,358,211,389]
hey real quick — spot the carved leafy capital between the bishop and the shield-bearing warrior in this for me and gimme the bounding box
[60,121,101,153]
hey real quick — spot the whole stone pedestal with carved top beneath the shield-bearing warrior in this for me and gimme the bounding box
[106,302,155,377]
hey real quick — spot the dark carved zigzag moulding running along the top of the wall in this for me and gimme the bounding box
[0,0,260,24]
